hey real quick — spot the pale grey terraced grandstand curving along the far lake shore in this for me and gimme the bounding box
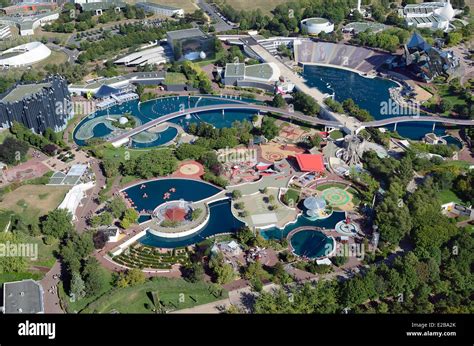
[295,41,388,73]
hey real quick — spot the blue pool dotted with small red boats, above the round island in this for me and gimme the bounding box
[124,178,221,212]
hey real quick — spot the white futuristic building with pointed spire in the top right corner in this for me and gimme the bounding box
[401,0,456,30]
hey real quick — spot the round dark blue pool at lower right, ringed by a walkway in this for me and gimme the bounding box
[290,230,333,258]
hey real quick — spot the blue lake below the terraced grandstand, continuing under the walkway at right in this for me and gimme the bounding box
[303,65,452,140]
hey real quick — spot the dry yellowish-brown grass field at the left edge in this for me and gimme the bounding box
[1,185,69,224]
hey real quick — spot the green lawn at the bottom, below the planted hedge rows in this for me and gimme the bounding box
[83,277,228,313]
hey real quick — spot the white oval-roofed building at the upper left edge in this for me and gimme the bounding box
[0,42,51,67]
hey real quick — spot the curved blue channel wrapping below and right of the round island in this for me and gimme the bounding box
[138,200,244,248]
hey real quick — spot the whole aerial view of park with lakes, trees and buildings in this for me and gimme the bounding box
[0,0,474,340]
